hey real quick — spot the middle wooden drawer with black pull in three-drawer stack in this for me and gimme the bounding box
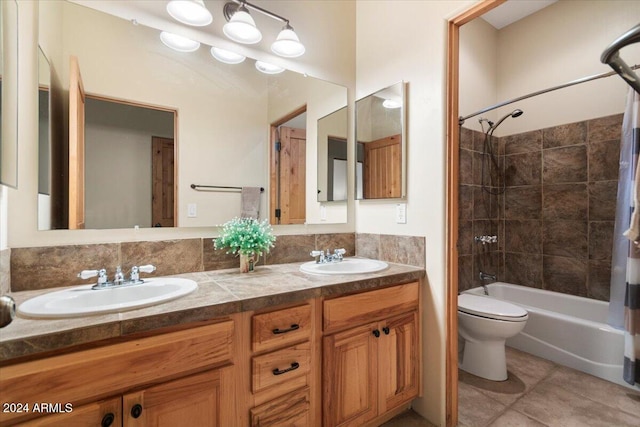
[251,341,311,393]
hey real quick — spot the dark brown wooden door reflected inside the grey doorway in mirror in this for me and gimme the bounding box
[151,136,175,227]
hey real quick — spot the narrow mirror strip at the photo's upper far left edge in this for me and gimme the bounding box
[0,0,18,188]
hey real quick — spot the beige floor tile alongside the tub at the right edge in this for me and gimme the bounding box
[544,366,640,418]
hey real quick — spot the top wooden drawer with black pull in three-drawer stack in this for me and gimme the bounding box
[251,304,311,352]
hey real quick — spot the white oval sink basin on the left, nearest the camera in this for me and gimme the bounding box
[18,277,198,318]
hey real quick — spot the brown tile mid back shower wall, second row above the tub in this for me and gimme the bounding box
[542,221,589,259]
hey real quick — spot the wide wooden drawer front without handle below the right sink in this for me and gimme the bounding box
[323,282,419,333]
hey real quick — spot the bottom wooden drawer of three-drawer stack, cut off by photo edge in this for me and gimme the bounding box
[251,387,311,427]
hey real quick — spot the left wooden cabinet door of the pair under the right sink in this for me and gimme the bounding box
[322,322,379,427]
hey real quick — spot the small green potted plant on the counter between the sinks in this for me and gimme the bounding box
[213,217,276,273]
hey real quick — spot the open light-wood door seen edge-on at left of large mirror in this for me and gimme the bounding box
[69,56,85,230]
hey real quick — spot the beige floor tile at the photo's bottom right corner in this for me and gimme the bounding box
[512,381,638,427]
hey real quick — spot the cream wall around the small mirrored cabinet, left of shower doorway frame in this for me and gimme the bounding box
[356,1,473,425]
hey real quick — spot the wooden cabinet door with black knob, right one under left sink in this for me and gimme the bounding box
[123,369,224,427]
